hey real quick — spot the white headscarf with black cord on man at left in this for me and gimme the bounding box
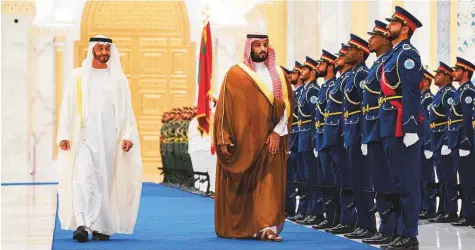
[82,35,124,83]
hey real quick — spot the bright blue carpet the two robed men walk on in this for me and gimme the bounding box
[52,183,375,250]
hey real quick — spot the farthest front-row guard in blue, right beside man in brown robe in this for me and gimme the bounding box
[289,61,308,221]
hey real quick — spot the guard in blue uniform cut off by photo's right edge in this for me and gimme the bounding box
[448,57,475,226]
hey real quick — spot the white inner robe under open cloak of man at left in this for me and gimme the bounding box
[73,69,117,231]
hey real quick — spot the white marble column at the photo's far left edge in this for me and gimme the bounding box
[1,1,36,182]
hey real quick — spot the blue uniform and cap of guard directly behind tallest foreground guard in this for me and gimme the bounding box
[361,20,395,240]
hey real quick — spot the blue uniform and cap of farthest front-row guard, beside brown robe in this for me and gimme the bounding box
[287,61,307,220]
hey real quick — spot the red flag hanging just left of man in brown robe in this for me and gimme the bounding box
[196,22,213,134]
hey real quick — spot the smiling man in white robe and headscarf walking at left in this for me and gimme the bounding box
[57,36,142,242]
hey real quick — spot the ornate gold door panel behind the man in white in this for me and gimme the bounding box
[75,1,196,182]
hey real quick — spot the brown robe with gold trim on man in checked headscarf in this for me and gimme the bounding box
[213,64,293,238]
